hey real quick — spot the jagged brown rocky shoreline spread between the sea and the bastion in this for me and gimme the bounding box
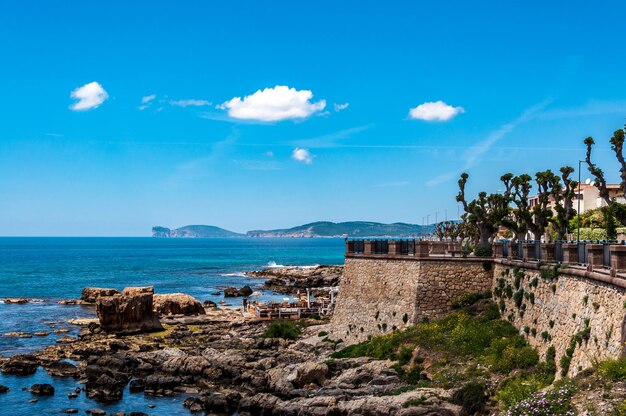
[0,276,459,416]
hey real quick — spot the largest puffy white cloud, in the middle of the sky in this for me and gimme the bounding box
[217,85,326,121]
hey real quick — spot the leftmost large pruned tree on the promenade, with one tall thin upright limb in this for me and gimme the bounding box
[456,173,509,255]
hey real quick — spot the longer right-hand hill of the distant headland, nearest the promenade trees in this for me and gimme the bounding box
[246,221,433,237]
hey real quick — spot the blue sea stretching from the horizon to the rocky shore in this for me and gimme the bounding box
[0,237,345,415]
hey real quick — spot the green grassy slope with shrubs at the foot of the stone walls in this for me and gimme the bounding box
[332,295,557,414]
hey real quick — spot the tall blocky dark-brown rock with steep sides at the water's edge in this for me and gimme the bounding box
[96,286,163,334]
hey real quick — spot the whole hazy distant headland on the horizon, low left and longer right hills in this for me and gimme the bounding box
[152,221,434,238]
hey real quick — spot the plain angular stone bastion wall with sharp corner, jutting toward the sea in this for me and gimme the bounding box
[330,257,493,344]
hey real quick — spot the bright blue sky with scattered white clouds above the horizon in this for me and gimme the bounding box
[0,0,626,236]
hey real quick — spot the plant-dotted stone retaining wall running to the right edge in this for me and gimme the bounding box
[493,264,626,376]
